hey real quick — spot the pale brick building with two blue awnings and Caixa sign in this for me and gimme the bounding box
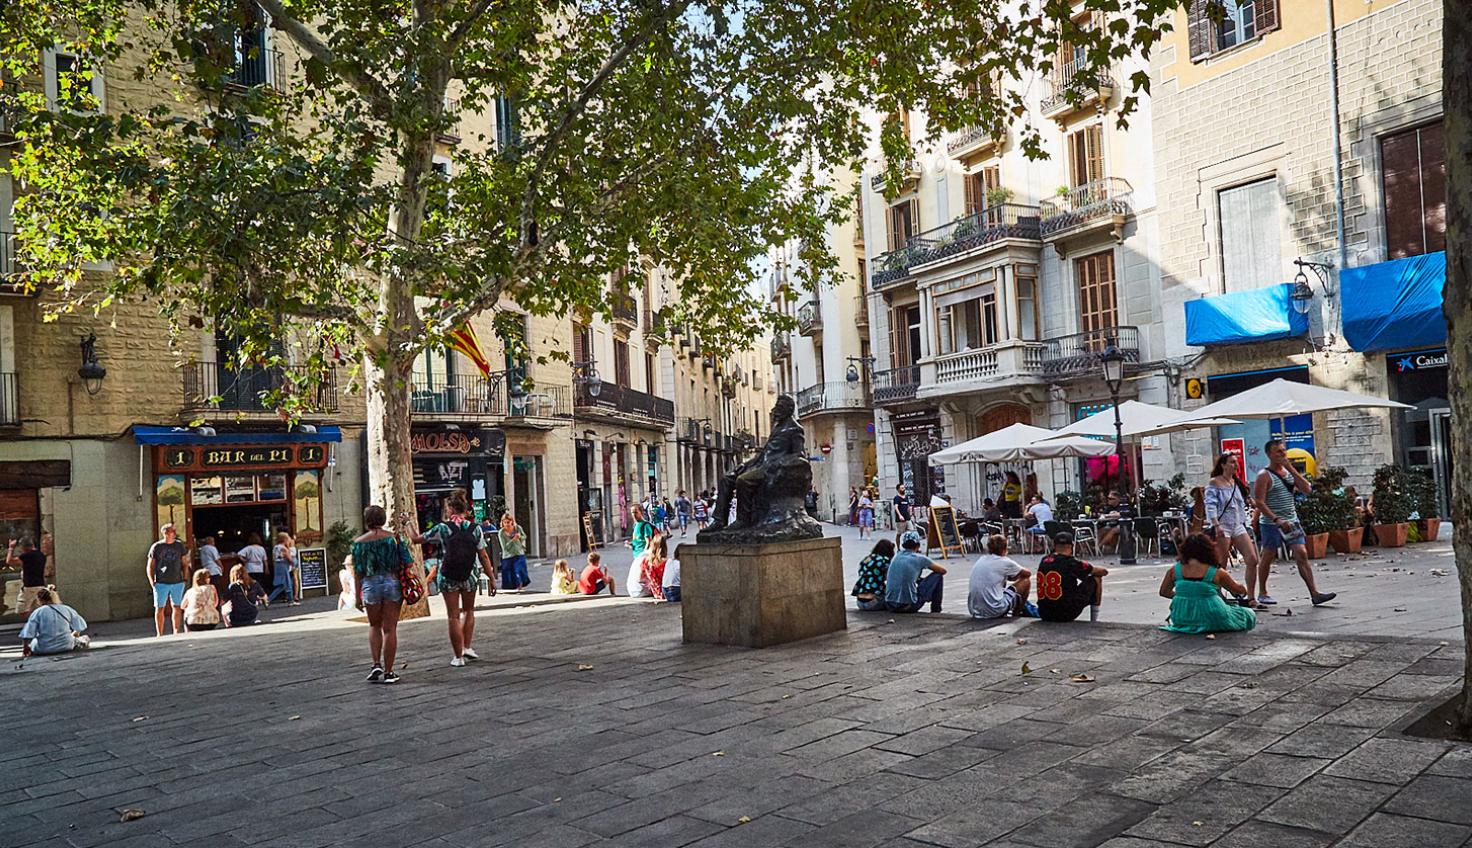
[1151,0,1450,503]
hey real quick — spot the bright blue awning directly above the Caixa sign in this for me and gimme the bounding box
[1340,252,1447,352]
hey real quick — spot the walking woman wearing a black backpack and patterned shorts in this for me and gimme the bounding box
[414,490,496,668]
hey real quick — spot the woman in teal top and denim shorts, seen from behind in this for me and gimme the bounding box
[353,504,414,683]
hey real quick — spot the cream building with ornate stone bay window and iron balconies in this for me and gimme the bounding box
[861,18,1167,511]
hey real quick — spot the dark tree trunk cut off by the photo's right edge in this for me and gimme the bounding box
[1441,0,1472,738]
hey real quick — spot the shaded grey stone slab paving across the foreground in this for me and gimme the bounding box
[0,585,1472,848]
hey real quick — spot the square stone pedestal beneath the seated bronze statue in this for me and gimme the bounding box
[680,539,848,648]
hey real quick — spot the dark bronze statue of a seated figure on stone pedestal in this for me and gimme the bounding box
[696,395,823,545]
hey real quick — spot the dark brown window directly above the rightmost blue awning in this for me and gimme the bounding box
[1381,121,1447,259]
